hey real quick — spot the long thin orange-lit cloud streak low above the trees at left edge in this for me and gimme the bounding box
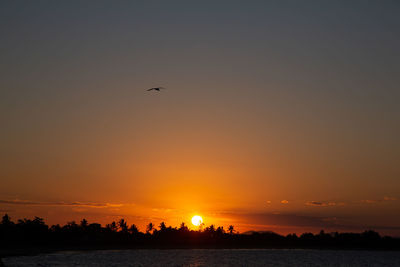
[0,199,125,208]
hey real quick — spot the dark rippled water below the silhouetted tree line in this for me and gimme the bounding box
[3,249,400,266]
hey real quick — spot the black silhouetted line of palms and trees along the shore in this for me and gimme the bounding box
[0,214,400,256]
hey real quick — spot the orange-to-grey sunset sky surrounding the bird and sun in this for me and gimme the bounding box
[0,0,400,236]
